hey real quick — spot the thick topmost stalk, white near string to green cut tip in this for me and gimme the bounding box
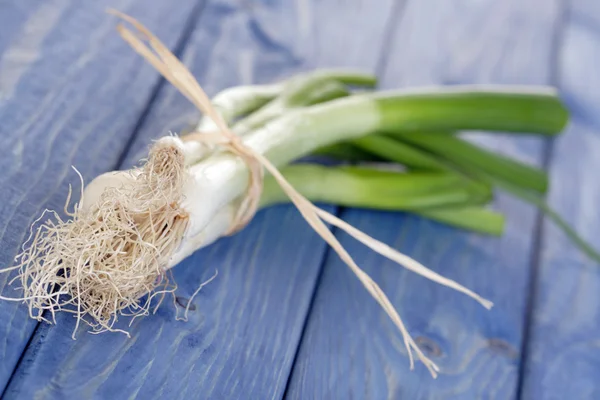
[250,86,564,165]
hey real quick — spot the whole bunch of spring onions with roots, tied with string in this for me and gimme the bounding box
[2,10,593,376]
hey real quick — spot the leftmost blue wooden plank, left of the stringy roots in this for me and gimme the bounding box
[0,0,204,393]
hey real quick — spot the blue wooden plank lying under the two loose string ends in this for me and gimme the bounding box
[287,0,558,399]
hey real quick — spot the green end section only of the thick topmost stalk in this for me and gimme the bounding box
[377,85,568,135]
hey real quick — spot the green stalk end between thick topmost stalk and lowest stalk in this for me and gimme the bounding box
[384,132,548,193]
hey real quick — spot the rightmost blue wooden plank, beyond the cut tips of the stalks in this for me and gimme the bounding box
[522,0,600,399]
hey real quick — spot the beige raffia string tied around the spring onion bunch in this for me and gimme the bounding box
[110,11,492,378]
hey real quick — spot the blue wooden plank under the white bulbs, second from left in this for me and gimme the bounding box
[7,0,392,399]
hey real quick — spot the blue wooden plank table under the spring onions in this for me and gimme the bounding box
[0,0,600,400]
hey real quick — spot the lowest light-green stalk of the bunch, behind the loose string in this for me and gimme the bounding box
[261,164,504,235]
